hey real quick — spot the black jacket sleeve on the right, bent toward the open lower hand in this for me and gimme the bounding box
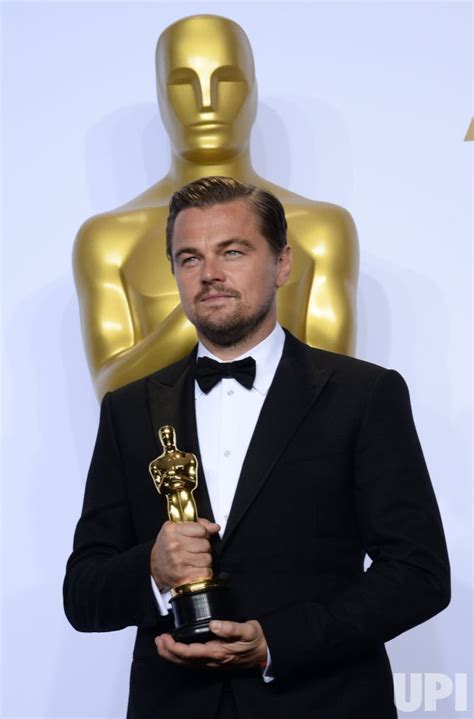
[258,370,450,679]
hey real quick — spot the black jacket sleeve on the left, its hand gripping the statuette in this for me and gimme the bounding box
[63,394,160,632]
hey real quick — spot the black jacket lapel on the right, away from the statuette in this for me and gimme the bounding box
[220,335,332,551]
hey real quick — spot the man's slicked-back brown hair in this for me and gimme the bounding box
[166,175,287,264]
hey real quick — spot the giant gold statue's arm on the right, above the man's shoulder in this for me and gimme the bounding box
[295,203,359,354]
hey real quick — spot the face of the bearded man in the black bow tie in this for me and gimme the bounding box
[171,200,291,347]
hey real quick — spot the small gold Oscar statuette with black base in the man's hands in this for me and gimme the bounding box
[149,425,231,644]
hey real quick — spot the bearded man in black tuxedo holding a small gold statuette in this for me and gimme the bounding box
[64,177,449,719]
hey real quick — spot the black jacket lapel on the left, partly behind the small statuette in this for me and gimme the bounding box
[147,351,214,522]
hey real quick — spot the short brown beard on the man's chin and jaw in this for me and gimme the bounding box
[193,291,275,348]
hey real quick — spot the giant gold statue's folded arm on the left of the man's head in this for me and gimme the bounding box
[73,217,196,398]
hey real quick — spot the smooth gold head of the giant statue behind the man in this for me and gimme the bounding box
[156,15,257,164]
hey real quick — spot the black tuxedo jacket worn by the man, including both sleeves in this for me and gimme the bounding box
[64,333,449,719]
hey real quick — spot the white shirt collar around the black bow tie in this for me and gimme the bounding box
[196,322,285,396]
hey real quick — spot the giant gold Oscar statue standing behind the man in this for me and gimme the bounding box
[74,15,358,397]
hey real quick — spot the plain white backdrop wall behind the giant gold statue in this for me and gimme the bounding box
[1,2,473,719]
